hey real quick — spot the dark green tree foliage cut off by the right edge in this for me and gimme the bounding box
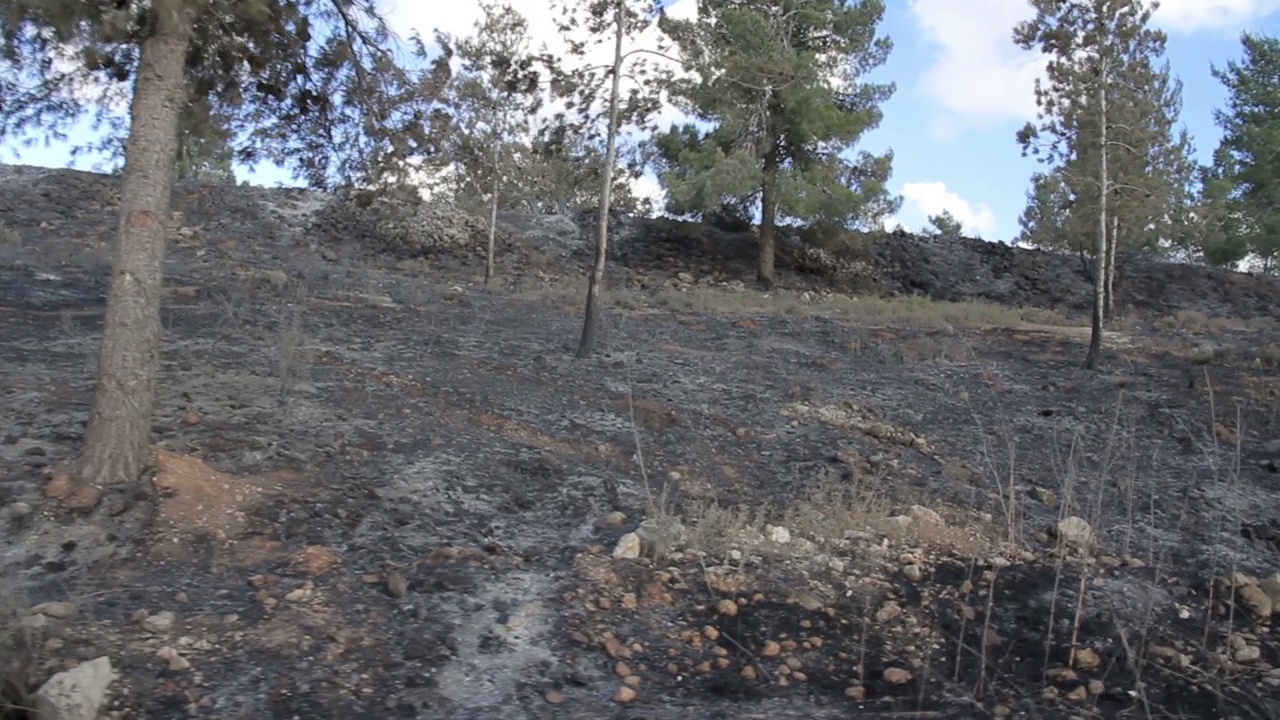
[1204,33,1280,269]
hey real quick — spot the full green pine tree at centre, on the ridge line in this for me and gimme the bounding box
[657,0,901,287]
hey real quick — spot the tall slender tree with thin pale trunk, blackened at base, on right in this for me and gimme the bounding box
[1014,0,1190,369]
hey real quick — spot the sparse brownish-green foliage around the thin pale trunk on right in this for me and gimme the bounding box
[1014,0,1196,254]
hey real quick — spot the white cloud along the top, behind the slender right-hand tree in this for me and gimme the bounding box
[909,0,1280,140]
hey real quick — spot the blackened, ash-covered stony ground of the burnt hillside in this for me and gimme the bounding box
[0,167,1280,719]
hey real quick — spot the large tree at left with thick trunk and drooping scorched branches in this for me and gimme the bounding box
[0,0,448,509]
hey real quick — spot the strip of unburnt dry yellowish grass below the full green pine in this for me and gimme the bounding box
[516,278,1080,330]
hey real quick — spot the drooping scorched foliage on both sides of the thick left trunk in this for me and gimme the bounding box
[0,0,448,187]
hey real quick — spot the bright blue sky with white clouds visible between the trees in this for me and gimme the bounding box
[0,0,1280,241]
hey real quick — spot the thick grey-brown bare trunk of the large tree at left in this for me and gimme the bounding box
[68,0,192,509]
